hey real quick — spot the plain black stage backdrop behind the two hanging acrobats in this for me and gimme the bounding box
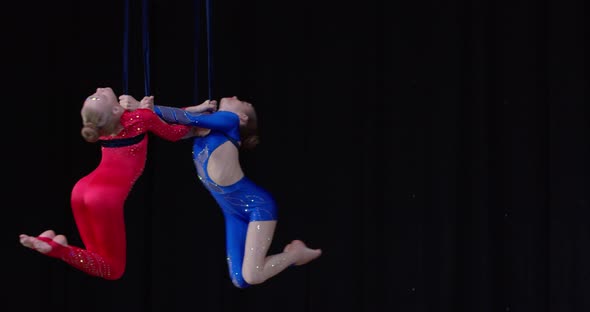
[2,0,590,312]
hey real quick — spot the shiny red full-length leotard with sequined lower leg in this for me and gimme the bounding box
[43,109,190,280]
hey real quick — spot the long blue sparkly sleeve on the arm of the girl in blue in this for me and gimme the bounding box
[154,105,240,133]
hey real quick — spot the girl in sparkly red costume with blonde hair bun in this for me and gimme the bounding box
[20,88,215,280]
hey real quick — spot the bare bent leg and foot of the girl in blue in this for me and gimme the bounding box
[242,220,322,285]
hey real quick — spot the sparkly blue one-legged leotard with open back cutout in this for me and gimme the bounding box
[154,105,277,288]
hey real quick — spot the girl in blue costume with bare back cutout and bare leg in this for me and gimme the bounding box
[126,96,322,288]
